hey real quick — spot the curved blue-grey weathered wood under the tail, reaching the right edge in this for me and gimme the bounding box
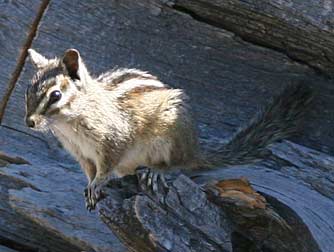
[192,141,334,251]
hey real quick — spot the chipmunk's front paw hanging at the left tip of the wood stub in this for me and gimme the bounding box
[84,178,104,212]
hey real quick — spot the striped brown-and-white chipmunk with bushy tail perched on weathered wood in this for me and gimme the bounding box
[25,49,312,210]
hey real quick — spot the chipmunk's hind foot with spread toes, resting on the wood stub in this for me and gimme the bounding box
[136,166,168,194]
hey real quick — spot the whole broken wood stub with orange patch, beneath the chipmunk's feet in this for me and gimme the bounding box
[98,168,320,252]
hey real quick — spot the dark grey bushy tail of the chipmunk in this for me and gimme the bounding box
[207,83,312,166]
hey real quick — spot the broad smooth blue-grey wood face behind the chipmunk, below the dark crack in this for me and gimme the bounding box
[5,0,334,154]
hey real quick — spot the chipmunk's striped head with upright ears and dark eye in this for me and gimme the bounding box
[25,49,90,130]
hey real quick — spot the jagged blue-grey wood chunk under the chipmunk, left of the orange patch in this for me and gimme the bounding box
[99,177,232,252]
